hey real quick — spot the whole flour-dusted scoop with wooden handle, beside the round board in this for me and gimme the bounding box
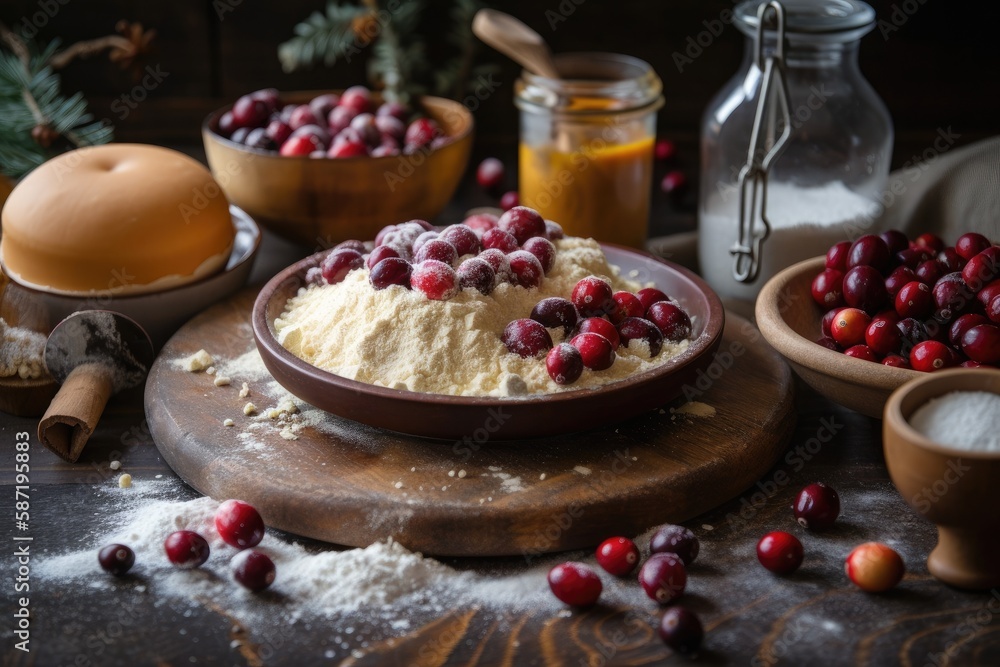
[38,310,153,463]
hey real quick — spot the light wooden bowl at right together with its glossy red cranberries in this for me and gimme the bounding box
[756,230,1000,419]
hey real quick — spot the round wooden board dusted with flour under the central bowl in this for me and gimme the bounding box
[145,290,795,557]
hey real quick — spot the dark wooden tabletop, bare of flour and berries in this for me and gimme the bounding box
[0,149,1000,667]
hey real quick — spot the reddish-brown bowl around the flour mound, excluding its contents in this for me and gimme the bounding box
[252,245,725,441]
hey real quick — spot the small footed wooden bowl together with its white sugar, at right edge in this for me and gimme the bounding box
[882,369,1000,590]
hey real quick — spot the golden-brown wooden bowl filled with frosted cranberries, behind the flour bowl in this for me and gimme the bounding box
[202,86,473,247]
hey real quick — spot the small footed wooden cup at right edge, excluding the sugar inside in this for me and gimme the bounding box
[882,369,1000,589]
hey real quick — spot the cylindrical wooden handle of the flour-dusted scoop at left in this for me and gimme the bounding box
[38,364,112,463]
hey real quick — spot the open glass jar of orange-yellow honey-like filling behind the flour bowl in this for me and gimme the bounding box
[515,53,663,248]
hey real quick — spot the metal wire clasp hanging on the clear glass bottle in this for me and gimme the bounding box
[729,1,792,283]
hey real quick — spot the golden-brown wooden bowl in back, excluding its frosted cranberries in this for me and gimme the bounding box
[202,92,473,248]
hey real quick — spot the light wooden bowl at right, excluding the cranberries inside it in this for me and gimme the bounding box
[756,257,924,419]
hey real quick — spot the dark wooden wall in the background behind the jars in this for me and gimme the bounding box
[0,0,1000,165]
